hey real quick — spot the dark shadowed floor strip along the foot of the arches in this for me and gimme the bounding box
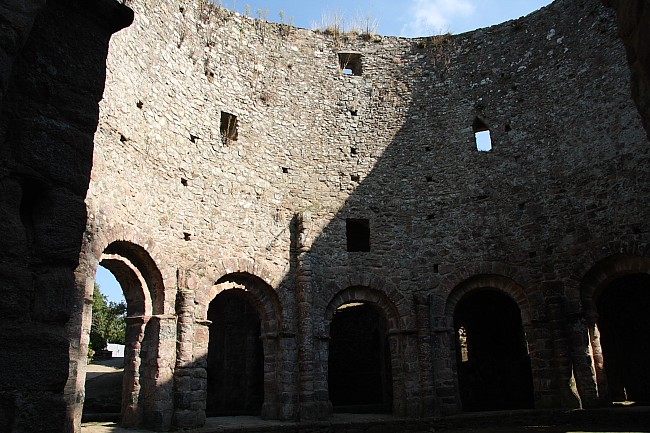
[81,407,650,433]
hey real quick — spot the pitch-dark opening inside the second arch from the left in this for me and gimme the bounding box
[206,290,264,416]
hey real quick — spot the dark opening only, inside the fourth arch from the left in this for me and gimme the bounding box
[454,289,534,411]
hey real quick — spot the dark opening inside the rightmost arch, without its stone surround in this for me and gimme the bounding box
[596,274,650,404]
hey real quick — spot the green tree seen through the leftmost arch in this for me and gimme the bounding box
[90,283,126,350]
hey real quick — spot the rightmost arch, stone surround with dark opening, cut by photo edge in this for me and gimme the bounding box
[580,254,650,403]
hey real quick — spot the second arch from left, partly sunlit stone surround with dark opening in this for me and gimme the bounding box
[195,272,284,419]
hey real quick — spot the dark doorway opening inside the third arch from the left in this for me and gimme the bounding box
[328,304,393,413]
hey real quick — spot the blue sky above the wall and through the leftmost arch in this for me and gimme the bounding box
[97,0,551,302]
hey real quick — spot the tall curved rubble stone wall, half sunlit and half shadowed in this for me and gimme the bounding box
[73,0,649,427]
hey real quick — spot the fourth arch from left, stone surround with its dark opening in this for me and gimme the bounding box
[434,274,536,411]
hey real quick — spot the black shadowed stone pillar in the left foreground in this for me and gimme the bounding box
[0,0,133,432]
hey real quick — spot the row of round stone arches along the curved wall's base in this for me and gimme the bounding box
[73,250,650,428]
